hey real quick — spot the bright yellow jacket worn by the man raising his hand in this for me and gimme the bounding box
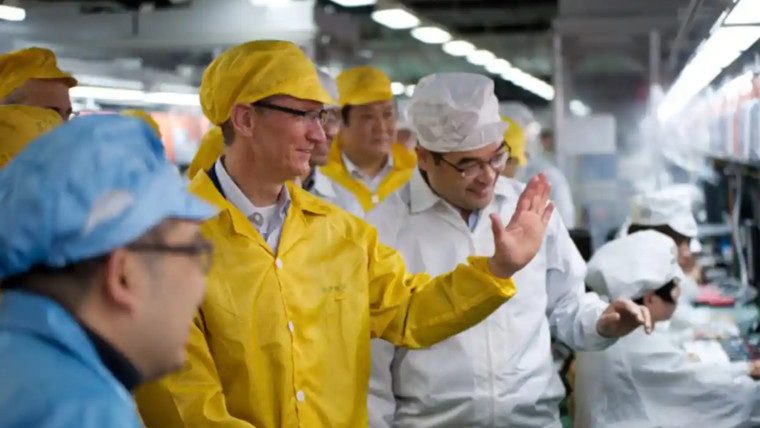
[136,171,515,428]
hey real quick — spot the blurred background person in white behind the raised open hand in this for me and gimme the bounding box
[502,102,576,229]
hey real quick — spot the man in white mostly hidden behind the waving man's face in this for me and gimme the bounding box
[299,70,364,217]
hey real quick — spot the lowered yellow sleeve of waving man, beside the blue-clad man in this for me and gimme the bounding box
[135,313,255,428]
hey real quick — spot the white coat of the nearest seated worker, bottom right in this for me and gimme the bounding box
[574,329,760,428]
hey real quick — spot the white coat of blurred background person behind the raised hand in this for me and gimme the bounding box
[517,154,576,229]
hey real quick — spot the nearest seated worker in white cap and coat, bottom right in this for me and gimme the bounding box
[574,230,760,428]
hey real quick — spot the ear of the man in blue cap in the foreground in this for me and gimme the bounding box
[103,248,140,312]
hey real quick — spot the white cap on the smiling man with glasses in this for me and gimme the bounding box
[407,73,509,153]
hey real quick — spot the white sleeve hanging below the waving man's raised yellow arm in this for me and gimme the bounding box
[367,339,396,428]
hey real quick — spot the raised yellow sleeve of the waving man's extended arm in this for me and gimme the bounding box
[368,229,516,348]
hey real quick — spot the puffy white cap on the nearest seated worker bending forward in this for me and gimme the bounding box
[586,230,684,300]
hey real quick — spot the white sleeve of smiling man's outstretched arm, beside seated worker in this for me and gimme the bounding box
[545,215,615,351]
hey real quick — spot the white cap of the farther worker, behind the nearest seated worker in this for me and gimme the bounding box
[631,188,699,238]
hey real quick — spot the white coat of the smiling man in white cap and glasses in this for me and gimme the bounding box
[367,171,614,428]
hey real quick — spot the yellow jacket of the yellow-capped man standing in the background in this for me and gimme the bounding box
[320,135,417,212]
